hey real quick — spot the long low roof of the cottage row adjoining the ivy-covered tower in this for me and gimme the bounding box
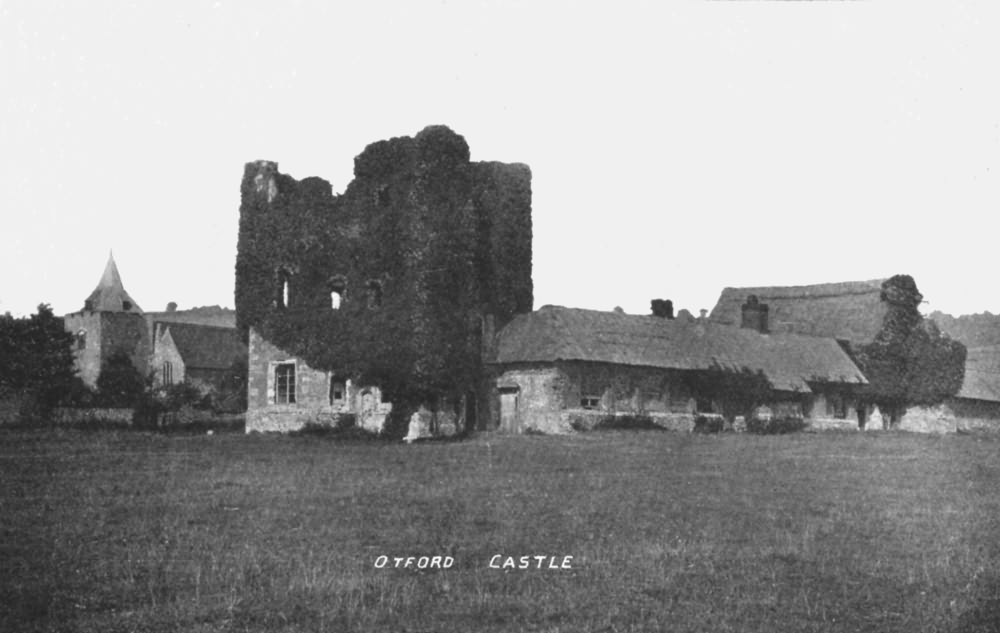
[494,306,867,391]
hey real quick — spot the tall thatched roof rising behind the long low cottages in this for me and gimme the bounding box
[709,279,886,343]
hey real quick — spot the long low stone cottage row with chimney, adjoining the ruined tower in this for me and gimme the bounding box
[493,298,867,432]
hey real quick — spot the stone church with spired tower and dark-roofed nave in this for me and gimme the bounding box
[63,256,247,393]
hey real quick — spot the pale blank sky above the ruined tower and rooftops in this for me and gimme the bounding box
[0,0,1000,314]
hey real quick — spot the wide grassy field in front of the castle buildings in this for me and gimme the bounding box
[0,430,1000,632]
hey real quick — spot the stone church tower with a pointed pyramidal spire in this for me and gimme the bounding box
[64,254,150,387]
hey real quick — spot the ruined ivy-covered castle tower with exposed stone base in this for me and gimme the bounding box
[236,126,533,430]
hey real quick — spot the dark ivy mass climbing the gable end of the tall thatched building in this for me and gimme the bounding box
[857,275,966,424]
